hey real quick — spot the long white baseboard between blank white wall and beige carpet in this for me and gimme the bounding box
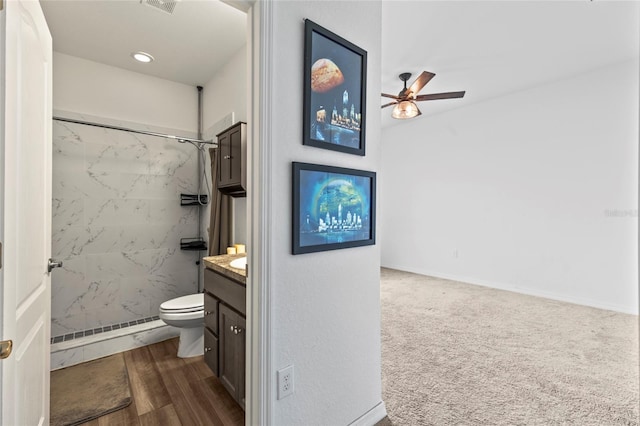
[382,265,639,315]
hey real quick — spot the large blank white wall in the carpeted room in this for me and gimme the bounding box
[381,59,639,313]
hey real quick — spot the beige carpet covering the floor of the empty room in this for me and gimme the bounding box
[381,269,640,426]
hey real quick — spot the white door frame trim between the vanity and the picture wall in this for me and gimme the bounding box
[224,0,274,425]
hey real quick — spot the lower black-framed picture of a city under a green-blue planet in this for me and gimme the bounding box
[292,162,376,254]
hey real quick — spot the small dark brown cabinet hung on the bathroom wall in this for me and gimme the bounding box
[217,122,247,197]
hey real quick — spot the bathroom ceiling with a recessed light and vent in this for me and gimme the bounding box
[40,0,247,86]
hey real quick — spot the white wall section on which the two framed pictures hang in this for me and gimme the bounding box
[261,1,384,426]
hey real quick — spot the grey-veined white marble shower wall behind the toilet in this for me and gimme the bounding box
[51,116,198,336]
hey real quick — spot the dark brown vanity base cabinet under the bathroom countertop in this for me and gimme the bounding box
[204,268,247,409]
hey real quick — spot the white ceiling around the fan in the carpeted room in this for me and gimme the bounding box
[380,0,640,127]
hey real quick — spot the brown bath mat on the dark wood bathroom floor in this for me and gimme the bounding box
[51,353,131,426]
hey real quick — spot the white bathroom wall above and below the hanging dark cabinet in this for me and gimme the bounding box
[202,45,247,244]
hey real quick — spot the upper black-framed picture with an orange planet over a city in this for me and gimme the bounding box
[303,19,367,155]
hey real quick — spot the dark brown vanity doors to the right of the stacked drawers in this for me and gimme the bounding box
[218,304,246,407]
